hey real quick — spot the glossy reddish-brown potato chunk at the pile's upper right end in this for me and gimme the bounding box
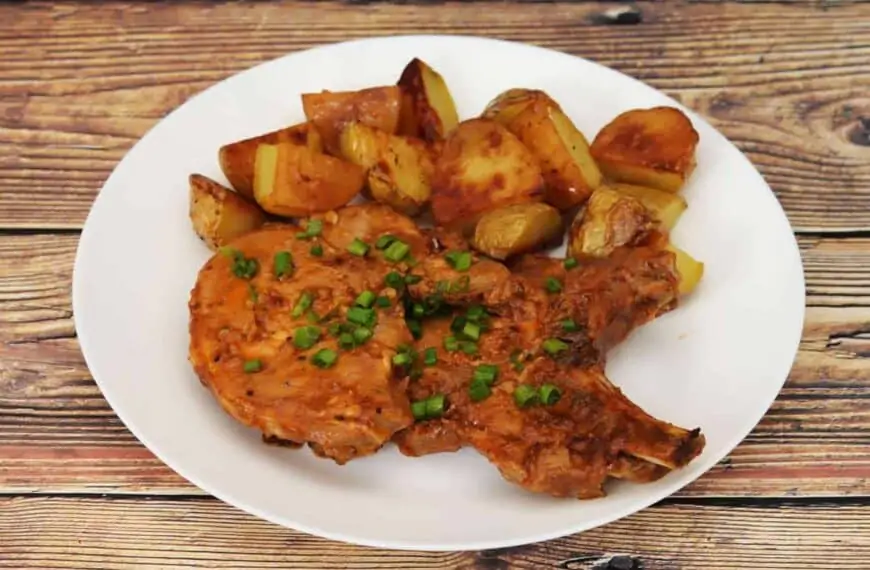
[591,107,698,192]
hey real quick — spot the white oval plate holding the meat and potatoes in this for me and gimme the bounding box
[73,36,804,550]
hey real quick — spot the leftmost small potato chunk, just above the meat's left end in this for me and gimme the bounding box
[189,174,266,246]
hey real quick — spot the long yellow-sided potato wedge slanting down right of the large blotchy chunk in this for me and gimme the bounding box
[503,96,601,210]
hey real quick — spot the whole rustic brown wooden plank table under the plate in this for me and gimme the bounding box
[0,0,870,569]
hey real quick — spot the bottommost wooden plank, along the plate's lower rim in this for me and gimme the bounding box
[0,497,870,570]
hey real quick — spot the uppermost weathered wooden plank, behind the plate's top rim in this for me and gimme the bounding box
[0,1,870,232]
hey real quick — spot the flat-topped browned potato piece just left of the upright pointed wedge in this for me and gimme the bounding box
[302,85,402,155]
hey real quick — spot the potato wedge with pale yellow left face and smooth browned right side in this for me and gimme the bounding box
[254,143,365,217]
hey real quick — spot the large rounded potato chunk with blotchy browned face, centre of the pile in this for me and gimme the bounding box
[432,119,544,231]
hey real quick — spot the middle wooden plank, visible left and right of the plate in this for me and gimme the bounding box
[0,234,870,496]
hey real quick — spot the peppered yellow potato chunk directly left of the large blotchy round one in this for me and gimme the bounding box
[340,123,435,216]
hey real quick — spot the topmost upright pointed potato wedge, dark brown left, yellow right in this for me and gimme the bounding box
[398,58,459,142]
